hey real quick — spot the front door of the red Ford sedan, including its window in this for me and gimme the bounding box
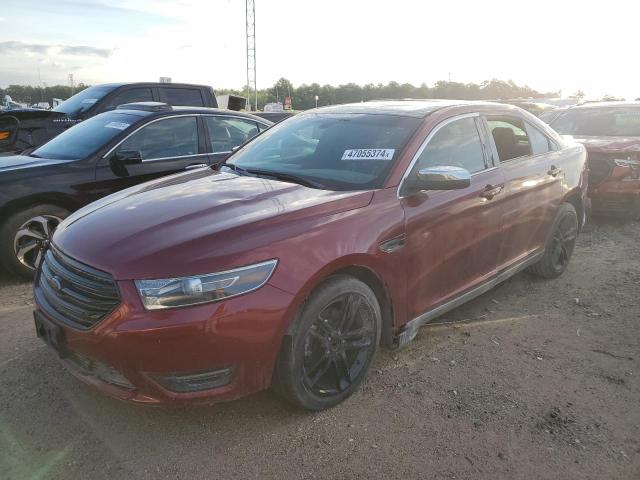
[400,114,504,318]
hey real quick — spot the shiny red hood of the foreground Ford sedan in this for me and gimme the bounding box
[53,169,373,280]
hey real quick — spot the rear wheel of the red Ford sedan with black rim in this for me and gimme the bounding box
[529,203,579,279]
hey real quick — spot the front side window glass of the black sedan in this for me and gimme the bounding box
[118,117,198,160]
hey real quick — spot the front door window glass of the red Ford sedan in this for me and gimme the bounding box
[415,117,486,173]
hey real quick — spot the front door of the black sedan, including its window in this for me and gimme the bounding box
[96,115,208,191]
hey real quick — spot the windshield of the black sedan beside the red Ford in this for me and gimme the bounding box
[31,112,140,160]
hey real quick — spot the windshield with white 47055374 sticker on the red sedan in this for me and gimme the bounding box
[227,113,421,190]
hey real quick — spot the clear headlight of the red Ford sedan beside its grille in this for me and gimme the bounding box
[135,260,278,310]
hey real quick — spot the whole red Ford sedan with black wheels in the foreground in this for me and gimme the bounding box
[34,101,587,410]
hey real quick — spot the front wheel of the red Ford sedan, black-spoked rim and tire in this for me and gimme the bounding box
[273,275,382,411]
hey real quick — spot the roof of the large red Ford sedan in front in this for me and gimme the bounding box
[308,99,508,118]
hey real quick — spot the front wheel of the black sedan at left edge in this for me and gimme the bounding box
[0,205,69,279]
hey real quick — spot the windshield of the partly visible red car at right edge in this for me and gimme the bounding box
[551,107,640,137]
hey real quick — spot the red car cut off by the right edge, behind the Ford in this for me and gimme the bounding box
[549,102,640,219]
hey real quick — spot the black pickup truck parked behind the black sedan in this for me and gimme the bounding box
[0,83,218,153]
